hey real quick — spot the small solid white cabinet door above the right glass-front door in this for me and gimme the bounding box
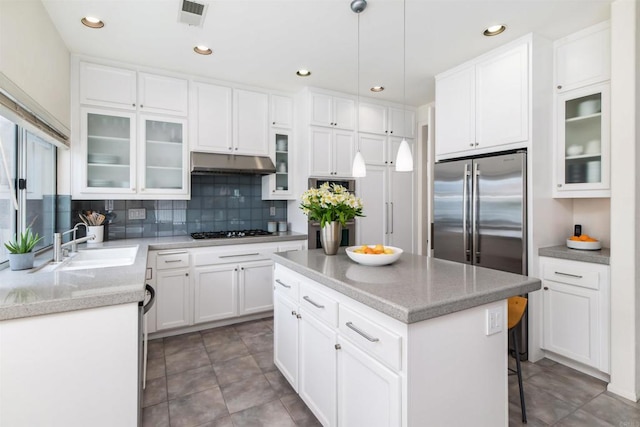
[138,73,189,117]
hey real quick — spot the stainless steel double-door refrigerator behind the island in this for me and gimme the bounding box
[432,152,528,358]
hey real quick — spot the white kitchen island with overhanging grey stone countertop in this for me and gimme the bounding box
[273,250,540,426]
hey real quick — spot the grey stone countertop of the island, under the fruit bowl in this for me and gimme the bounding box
[272,249,541,323]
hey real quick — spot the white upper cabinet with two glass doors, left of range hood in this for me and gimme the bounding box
[72,61,189,199]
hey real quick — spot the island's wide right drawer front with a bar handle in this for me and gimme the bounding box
[338,304,402,370]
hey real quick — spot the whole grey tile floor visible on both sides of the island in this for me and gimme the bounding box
[143,319,640,427]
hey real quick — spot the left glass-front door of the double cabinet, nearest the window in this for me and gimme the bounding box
[80,108,136,193]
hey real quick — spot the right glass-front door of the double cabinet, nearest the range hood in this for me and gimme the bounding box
[138,115,188,194]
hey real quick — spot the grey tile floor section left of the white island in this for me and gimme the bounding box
[143,318,320,427]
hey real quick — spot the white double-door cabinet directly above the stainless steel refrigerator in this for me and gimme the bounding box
[435,40,530,157]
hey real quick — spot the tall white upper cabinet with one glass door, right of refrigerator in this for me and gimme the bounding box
[553,22,611,198]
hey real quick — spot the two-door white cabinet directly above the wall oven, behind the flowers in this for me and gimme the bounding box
[309,126,354,177]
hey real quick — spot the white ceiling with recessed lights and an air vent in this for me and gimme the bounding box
[42,0,611,106]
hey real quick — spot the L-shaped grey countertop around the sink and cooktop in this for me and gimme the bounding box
[0,232,307,320]
